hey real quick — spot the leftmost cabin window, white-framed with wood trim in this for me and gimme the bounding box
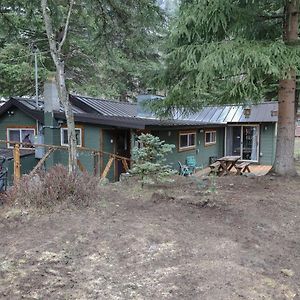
[7,128,35,149]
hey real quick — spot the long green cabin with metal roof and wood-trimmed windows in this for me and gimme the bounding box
[0,82,278,184]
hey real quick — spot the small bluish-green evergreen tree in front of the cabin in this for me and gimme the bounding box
[130,134,176,186]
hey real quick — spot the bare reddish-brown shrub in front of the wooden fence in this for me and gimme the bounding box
[6,165,100,209]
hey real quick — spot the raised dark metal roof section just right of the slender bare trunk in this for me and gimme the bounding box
[70,95,137,117]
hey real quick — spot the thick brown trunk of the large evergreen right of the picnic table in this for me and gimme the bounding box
[273,0,299,176]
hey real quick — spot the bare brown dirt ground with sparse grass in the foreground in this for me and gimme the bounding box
[0,176,300,300]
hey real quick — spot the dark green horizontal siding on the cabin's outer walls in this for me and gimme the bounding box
[0,108,276,183]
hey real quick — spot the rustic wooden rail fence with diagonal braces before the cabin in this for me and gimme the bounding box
[0,140,131,183]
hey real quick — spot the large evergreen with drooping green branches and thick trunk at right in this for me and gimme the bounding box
[159,0,300,175]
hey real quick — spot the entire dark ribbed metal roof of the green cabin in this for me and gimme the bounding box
[0,95,278,129]
